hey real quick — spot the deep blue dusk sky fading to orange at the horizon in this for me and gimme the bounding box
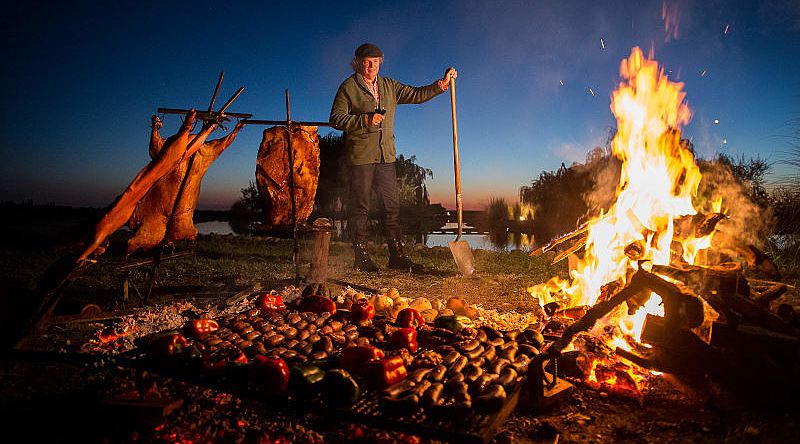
[0,0,800,209]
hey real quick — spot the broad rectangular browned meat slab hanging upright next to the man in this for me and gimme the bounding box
[256,125,319,227]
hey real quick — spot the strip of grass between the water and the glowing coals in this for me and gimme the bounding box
[0,233,566,318]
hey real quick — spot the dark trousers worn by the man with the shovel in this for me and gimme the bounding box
[348,162,400,242]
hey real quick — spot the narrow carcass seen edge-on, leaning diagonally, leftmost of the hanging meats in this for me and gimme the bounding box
[77,112,217,263]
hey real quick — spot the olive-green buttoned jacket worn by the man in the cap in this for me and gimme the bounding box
[330,73,443,165]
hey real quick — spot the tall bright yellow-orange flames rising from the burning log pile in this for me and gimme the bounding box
[528,47,722,392]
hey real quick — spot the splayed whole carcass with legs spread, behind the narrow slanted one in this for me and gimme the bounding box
[126,116,243,255]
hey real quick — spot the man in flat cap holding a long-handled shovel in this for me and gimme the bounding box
[330,43,457,272]
